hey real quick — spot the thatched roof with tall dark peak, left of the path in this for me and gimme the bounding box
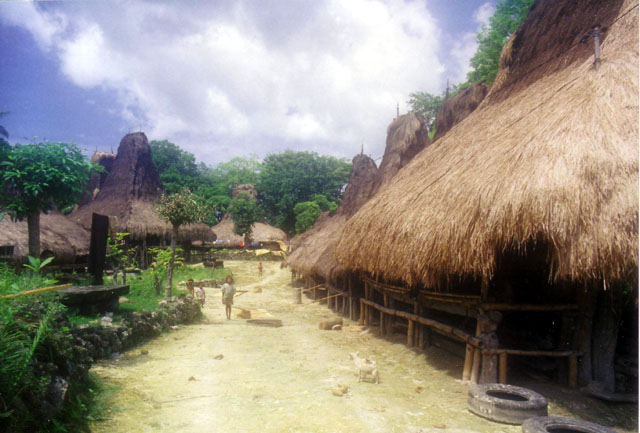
[69,132,213,242]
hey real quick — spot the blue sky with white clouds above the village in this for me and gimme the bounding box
[0,0,495,165]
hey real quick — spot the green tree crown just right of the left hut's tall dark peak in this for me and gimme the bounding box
[149,140,202,194]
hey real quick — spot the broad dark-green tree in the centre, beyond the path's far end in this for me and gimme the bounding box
[256,150,351,234]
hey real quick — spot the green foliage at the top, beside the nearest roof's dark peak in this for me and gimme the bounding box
[467,0,533,84]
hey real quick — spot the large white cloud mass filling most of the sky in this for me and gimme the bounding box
[2,0,450,163]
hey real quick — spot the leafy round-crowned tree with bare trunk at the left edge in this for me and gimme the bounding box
[0,143,100,257]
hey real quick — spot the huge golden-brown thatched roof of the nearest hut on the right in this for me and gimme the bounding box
[336,0,638,285]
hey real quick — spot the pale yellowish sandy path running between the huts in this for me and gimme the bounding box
[92,261,637,433]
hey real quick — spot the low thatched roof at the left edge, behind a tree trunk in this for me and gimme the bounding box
[0,212,90,264]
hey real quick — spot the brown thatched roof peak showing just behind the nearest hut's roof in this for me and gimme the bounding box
[433,83,489,141]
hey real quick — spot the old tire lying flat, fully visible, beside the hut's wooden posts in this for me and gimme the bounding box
[468,383,548,424]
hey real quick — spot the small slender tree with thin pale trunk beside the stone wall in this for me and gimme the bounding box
[158,188,202,297]
